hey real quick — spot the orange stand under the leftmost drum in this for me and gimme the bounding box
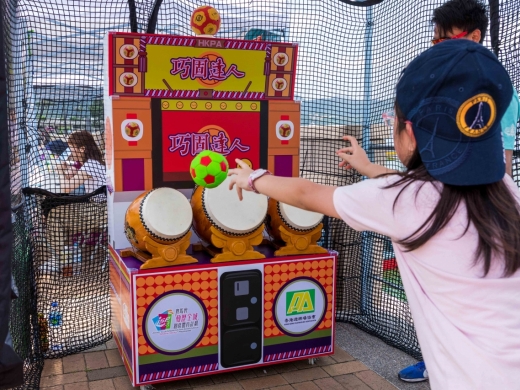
[121,232,197,269]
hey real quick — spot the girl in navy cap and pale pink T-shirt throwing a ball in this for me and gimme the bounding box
[229,40,520,390]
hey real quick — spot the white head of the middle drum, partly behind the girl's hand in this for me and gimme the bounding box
[202,177,267,234]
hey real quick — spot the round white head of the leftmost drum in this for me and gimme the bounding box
[140,187,193,240]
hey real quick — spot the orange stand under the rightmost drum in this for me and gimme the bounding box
[274,223,328,256]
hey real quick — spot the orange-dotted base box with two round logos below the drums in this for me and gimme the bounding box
[110,248,336,386]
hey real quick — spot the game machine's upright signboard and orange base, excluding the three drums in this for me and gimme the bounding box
[105,32,336,386]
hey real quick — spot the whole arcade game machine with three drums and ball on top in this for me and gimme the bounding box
[105,7,336,386]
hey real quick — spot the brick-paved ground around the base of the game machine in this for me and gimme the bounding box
[40,340,396,390]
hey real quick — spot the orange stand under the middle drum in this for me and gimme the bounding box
[197,224,265,263]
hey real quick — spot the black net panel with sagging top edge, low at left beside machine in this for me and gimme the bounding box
[23,187,110,357]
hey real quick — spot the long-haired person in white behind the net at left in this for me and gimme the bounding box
[61,130,106,194]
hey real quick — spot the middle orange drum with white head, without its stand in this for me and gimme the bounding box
[191,178,267,244]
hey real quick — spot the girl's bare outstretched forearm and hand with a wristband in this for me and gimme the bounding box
[228,159,341,219]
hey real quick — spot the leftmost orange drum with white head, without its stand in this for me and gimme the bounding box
[125,187,193,252]
